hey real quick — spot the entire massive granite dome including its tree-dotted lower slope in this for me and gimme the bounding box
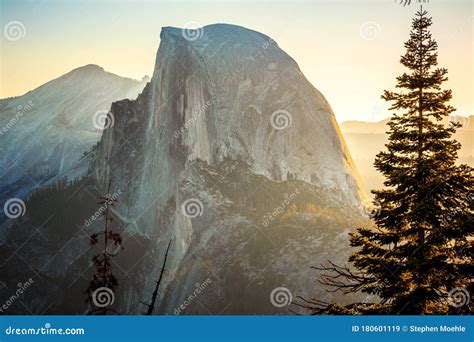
[92,24,365,314]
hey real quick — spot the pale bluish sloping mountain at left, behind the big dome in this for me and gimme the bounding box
[0,65,146,221]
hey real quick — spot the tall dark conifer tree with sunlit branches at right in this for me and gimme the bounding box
[298,8,474,315]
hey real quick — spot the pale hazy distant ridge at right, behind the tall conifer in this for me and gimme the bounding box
[340,115,474,192]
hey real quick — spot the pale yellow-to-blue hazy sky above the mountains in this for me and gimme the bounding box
[0,0,474,122]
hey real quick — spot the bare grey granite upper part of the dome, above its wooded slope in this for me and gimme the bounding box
[94,24,364,233]
